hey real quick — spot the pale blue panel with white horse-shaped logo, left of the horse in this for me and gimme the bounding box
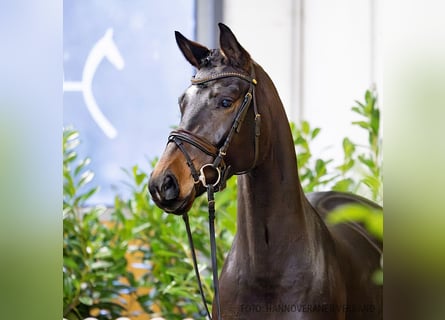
[63,0,195,204]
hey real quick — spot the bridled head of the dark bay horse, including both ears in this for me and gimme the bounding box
[149,24,260,214]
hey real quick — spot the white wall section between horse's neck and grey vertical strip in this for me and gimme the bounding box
[223,0,295,119]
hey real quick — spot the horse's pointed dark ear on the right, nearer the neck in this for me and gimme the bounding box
[218,23,250,71]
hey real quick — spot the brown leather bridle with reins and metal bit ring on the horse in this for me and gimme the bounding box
[168,65,261,320]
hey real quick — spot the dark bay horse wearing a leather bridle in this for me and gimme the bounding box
[149,24,382,320]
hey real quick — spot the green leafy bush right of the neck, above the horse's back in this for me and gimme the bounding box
[290,90,383,203]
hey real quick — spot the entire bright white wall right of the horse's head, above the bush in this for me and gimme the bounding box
[223,0,381,159]
